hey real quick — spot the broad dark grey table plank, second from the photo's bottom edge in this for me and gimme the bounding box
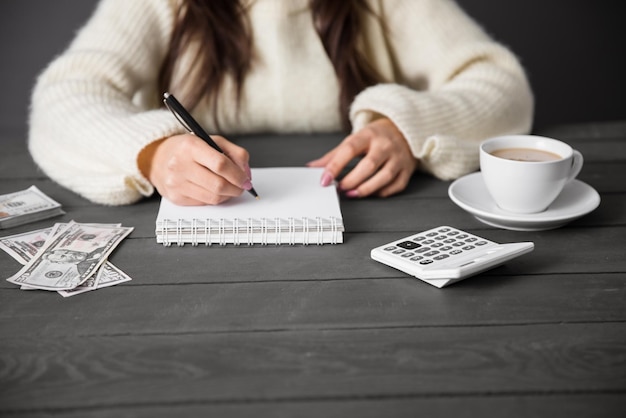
[0,324,626,411]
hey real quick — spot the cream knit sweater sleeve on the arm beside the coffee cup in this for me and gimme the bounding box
[350,0,533,180]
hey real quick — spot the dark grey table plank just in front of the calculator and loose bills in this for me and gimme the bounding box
[0,269,626,338]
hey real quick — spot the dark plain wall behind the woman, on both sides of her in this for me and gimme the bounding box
[0,0,626,135]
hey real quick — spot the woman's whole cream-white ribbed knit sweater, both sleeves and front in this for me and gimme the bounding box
[29,0,533,205]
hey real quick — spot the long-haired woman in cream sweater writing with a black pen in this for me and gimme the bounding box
[29,0,533,205]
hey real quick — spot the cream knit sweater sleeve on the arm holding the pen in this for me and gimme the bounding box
[28,0,180,205]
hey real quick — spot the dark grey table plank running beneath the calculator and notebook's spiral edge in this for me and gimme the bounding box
[0,227,626,289]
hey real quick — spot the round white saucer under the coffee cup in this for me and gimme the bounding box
[448,172,600,231]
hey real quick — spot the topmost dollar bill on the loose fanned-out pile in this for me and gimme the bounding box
[7,222,133,291]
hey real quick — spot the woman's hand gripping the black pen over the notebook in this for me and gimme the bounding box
[138,134,252,205]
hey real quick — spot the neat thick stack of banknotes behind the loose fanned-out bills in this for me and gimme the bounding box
[0,186,65,229]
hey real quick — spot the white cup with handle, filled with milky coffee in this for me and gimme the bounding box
[480,135,583,213]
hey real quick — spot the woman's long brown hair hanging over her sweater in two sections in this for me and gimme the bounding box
[159,0,380,130]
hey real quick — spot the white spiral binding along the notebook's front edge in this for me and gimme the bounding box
[156,217,343,247]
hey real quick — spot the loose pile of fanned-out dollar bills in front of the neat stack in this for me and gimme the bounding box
[0,221,133,297]
